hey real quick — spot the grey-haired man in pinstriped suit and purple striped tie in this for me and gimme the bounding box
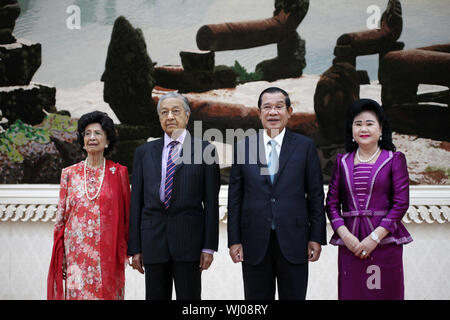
[128,93,220,300]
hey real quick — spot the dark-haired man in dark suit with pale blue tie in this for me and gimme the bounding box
[227,87,326,300]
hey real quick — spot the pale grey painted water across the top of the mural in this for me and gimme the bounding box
[15,0,450,88]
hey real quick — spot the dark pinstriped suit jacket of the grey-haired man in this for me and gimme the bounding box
[128,135,220,264]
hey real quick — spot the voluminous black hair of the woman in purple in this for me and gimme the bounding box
[345,99,396,152]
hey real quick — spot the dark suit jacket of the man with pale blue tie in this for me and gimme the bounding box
[227,130,326,265]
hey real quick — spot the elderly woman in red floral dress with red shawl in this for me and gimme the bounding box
[47,111,130,300]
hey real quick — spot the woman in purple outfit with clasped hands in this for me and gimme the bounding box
[326,99,412,300]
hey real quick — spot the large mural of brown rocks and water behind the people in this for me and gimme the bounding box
[0,0,450,184]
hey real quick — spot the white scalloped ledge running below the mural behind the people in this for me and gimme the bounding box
[0,184,450,224]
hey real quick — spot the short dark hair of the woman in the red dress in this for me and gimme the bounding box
[77,111,118,156]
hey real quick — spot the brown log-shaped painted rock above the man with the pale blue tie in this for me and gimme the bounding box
[196,0,309,81]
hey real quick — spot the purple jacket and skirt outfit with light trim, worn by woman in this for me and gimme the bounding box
[326,150,412,300]
